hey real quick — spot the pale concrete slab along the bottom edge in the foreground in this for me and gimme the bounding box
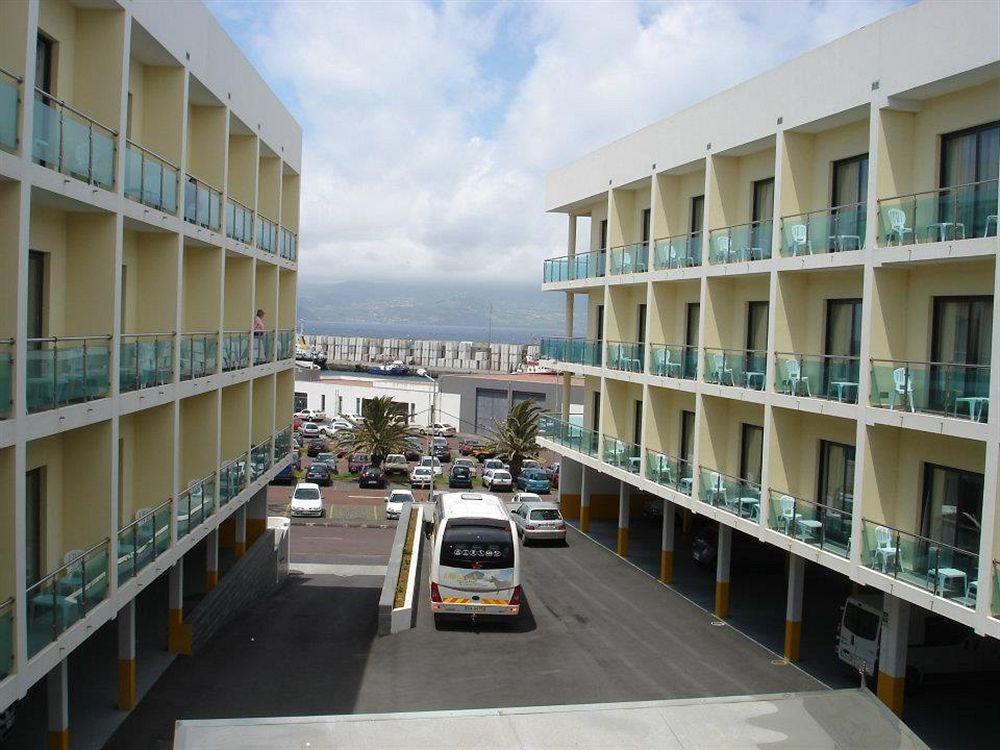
[174,690,926,750]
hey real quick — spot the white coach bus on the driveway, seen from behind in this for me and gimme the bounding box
[430,492,521,617]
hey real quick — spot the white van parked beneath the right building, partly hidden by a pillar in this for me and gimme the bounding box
[836,593,1000,687]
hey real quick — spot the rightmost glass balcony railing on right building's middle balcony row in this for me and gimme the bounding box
[871,359,990,422]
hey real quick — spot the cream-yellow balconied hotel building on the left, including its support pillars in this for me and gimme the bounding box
[0,0,301,746]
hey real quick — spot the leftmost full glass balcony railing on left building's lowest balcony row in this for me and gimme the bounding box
[25,539,111,658]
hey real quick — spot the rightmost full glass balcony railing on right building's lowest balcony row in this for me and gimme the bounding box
[861,518,979,609]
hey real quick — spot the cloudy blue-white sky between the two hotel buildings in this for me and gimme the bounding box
[209,0,907,284]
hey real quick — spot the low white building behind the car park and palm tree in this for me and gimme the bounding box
[295,375,462,427]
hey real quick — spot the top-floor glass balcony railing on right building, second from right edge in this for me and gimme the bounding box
[781,203,868,258]
